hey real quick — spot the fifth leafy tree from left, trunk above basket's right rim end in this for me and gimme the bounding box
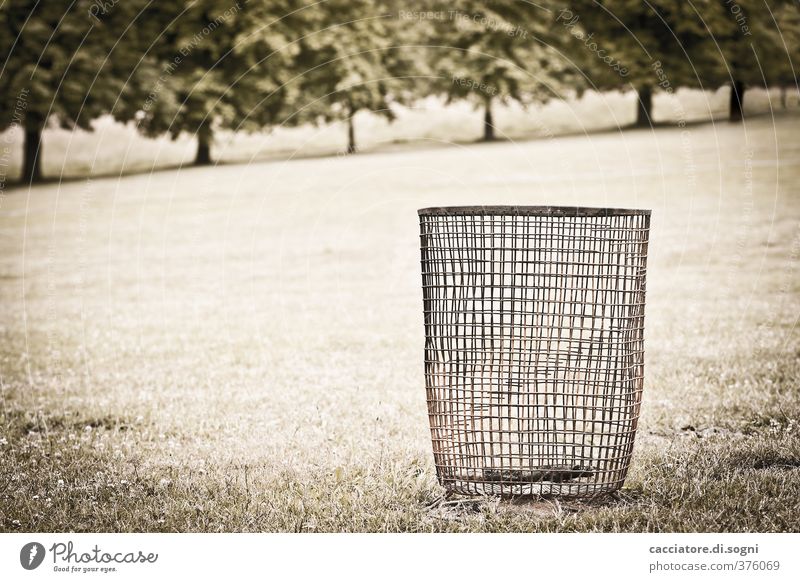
[557,0,722,126]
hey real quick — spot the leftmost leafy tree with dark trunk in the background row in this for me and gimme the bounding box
[0,0,152,182]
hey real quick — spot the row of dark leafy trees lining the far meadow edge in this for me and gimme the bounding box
[0,0,800,181]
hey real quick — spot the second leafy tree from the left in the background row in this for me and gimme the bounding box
[138,0,302,165]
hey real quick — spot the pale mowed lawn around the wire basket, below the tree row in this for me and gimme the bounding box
[0,114,800,531]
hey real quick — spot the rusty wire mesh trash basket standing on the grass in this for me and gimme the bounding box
[419,206,650,497]
